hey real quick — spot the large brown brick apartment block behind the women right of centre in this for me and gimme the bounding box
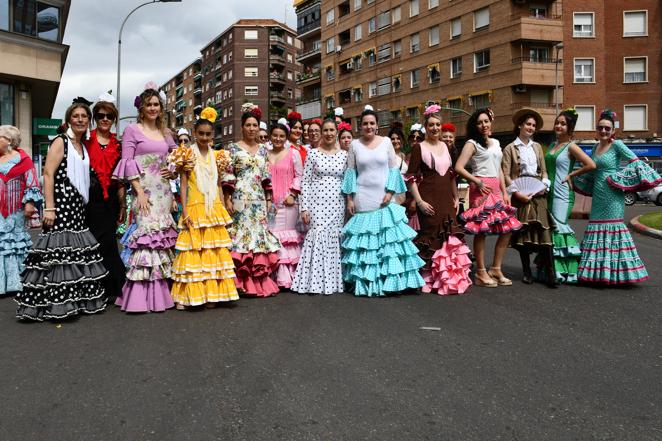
[321,0,563,136]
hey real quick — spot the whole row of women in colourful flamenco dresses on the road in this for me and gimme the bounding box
[0,84,662,320]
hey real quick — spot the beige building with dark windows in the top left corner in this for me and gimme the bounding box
[0,0,73,156]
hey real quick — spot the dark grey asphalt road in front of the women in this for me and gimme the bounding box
[0,205,662,441]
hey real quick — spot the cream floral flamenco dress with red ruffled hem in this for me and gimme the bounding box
[223,143,280,297]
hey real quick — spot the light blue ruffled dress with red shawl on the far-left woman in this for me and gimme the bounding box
[0,149,43,295]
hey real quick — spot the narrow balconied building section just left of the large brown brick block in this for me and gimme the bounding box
[294,0,327,120]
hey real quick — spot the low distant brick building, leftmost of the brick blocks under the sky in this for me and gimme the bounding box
[161,58,202,132]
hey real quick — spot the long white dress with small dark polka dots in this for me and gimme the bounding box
[292,149,347,294]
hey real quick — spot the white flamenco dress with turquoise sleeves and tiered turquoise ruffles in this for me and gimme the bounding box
[342,137,425,297]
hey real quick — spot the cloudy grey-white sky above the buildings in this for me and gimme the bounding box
[53,0,296,118]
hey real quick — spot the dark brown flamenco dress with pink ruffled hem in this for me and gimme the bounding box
[408,142,471,295]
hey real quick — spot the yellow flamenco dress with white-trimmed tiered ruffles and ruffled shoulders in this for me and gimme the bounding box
[171,147,239,306]
